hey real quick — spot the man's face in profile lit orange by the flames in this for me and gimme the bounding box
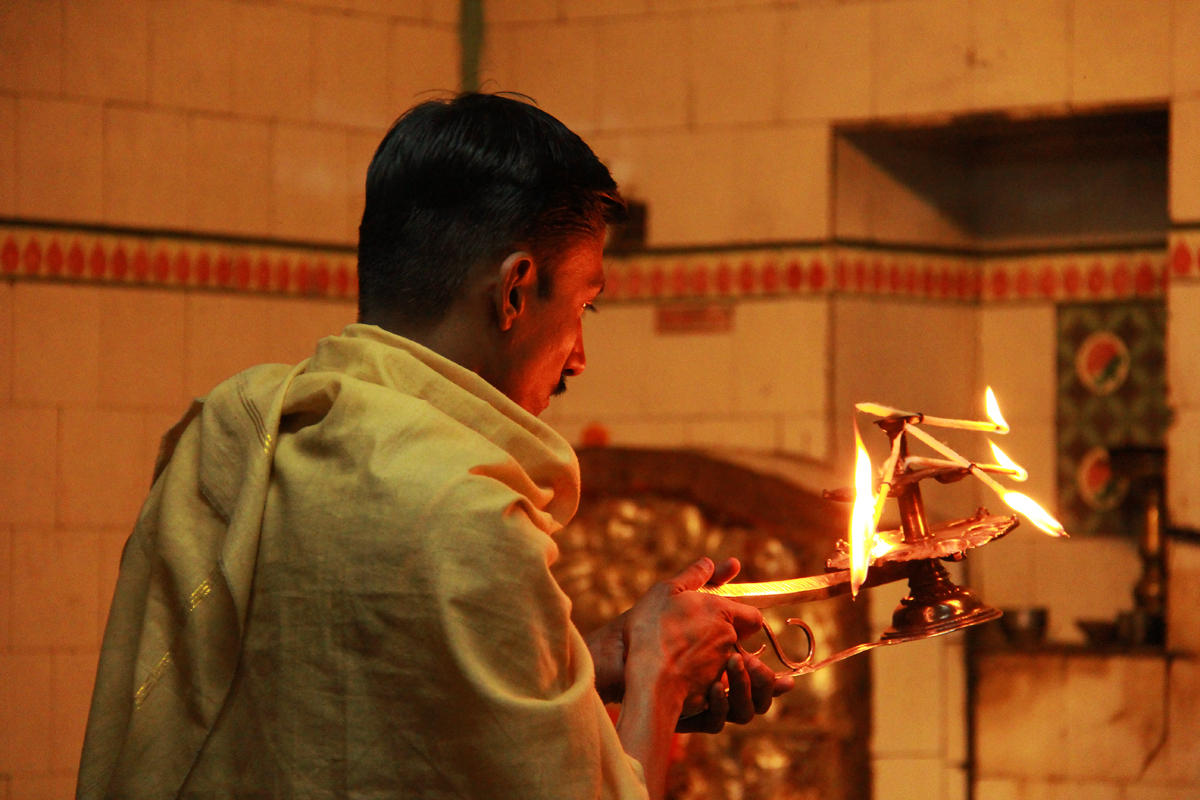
[496,236,604,414]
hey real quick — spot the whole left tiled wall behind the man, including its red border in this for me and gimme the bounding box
[0,0,460,800]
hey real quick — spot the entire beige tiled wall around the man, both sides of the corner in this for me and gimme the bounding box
[0,0,1200,800]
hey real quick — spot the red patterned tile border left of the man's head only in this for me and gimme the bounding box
[0,225,358,299]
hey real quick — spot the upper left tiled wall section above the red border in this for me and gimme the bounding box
[0,0,458,243]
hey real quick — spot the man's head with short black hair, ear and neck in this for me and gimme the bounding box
[359,94,624,414]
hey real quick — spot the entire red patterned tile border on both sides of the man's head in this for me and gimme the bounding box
[0,223,1200,302]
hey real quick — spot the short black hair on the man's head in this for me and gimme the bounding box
[359,92,625,323]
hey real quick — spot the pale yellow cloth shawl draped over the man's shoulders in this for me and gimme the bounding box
[78,325,646,800]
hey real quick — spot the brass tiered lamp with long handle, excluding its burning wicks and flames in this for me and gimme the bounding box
[701,419,1019,676]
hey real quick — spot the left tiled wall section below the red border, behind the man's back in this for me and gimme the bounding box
[0,281,354,799]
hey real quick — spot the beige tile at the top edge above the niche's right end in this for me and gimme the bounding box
[1070,0,1171,103]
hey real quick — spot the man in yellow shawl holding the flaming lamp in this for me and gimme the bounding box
[78,95,791,799]
